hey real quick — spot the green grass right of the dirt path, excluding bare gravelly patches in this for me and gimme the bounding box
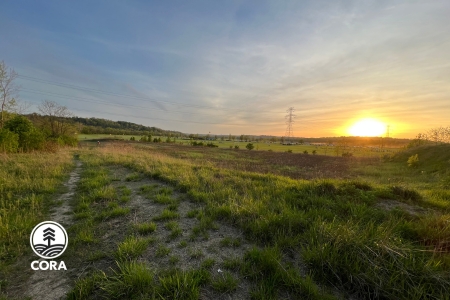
[28,146,450,299]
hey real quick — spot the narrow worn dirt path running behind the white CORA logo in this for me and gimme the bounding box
[23,160,81,300]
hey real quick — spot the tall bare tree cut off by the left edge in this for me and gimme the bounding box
[0,61,19,128]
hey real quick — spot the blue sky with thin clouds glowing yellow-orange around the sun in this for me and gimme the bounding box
[0,0,450,138]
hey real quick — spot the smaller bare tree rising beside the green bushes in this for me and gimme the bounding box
[38,100,73,137]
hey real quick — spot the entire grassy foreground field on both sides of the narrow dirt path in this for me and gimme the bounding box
[0,142,450,299]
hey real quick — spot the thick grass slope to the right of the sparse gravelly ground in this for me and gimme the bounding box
[68,147,450,299]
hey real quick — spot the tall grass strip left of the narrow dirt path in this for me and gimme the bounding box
[0,151,73,271]
